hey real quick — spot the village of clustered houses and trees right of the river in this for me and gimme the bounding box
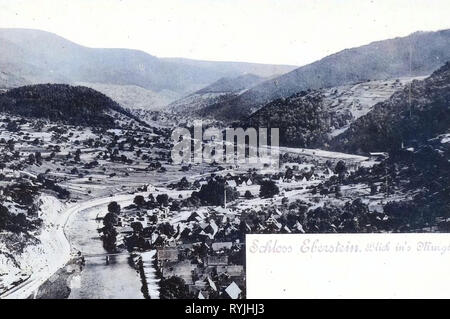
[95,138,394,299]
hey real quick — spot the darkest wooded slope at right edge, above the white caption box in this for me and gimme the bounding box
[327,63,450,232]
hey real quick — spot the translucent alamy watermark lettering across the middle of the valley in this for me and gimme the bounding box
[171,121,280,169]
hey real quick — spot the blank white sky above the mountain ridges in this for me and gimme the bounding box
[0,0,450,66]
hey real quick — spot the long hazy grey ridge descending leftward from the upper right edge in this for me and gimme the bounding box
[205,30,450,120]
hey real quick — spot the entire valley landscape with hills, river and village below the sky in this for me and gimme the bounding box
[0,26,450,299]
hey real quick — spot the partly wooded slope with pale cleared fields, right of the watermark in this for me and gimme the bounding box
[239,78,420,147]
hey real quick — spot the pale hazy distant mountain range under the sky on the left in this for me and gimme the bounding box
[0,29,294,96]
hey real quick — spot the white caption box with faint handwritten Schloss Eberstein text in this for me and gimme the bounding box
[246,234,450,299]
